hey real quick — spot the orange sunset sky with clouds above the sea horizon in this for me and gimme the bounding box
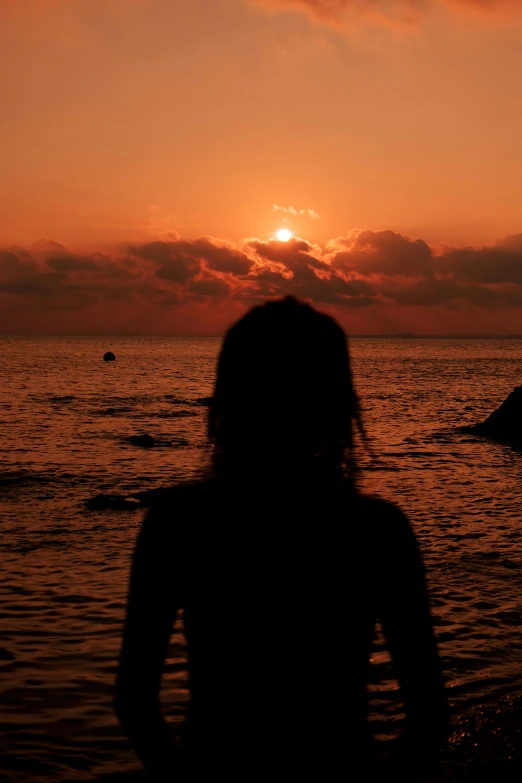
[0,0,522,335]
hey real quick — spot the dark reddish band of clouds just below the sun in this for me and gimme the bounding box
[0,229,522,333]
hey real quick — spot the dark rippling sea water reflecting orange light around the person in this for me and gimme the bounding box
[0,338,522,783]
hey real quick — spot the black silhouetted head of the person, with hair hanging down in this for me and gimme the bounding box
[208,297,360,480]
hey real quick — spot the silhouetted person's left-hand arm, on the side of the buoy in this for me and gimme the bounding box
[114,512,178,781]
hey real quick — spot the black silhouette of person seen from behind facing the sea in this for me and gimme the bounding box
[116,298,447,783]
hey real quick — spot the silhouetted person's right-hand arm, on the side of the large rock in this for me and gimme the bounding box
[374,506,449,769]
